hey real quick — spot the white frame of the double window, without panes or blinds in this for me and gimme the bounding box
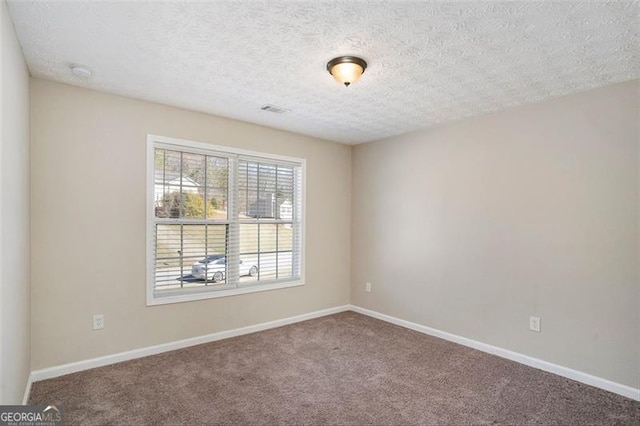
[146,134,306,306]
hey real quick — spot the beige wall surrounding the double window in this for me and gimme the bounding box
[31,79,351,370]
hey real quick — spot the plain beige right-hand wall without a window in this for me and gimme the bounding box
[351,81,640,388]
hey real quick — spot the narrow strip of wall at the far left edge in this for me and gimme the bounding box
[0,0,30,404]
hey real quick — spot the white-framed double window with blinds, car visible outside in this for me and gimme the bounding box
[147,135,305,305]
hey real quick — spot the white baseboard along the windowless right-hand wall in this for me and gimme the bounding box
[349,305,640,401]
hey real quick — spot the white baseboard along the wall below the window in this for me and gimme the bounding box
[25,305,349,382]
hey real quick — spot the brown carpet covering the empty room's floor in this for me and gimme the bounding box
[29,312,640,425]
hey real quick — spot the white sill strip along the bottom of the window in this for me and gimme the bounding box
[147,280,304,306]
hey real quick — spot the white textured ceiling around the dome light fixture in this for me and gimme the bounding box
[9,1,640,144]
